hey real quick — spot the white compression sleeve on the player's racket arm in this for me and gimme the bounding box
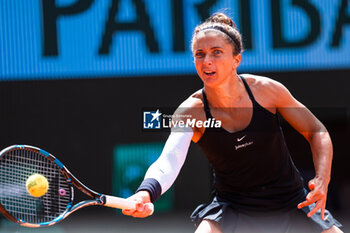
[145,129,193,194]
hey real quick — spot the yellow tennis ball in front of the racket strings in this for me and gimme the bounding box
[26,173,49,197]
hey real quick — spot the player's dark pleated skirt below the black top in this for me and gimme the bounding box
[191,193,342,233]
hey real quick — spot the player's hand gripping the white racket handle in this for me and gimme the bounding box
[122,191,153,218]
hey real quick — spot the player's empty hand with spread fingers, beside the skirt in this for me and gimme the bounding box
[298,177,329,220]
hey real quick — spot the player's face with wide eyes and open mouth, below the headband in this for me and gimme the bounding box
[192,31,241,87]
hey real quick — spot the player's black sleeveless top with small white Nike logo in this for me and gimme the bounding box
[198,77,305,211]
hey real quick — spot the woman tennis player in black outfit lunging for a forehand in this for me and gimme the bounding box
[123,13,342,233]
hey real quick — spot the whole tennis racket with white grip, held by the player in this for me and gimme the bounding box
[0,145,153,227]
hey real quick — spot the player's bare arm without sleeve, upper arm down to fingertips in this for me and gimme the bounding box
[273,82,333,220]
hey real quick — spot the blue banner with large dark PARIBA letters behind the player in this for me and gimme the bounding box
[0,0,350,80]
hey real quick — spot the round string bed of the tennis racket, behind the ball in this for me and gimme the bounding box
[0,149,72,224]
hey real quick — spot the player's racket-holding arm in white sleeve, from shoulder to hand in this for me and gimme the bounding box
[123,90,205,218]
